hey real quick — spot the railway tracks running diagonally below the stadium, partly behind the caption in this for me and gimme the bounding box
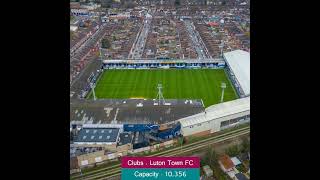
[71,127,250,180]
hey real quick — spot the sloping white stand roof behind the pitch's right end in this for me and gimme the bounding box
[223,50,250,97]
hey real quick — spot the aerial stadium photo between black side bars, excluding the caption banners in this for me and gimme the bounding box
[70,0,250,180]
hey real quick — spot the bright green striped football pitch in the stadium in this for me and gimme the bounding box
[90,69,237,107]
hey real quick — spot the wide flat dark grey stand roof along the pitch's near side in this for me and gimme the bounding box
[70,99,204,124]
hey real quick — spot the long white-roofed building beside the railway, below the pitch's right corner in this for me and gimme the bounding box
[178,96,250,136]
